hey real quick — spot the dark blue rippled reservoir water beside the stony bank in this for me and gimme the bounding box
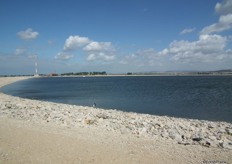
[0,77,232,122]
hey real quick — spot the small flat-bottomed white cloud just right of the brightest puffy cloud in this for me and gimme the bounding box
[84,41,113,51]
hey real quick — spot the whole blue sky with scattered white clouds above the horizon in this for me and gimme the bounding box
[0,0,232,75]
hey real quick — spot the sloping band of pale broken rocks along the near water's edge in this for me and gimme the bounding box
[0,89,232,149]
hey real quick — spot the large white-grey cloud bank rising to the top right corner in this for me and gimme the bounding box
[119,0,232,70]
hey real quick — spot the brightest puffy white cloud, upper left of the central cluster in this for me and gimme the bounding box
[64,35,91,51]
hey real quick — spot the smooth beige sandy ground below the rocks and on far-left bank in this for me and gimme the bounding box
[0,77,232,164]
